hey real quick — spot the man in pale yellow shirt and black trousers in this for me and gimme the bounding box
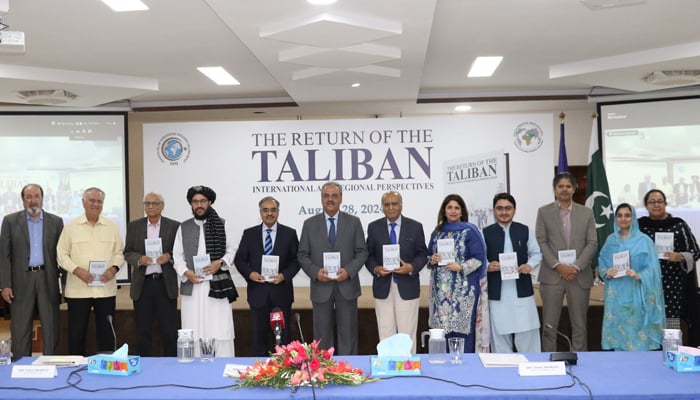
[57,187,124,355]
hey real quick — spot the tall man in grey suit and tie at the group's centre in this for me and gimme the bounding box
[297,182,367,355]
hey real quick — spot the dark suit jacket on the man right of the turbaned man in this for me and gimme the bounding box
[233,222,299,308]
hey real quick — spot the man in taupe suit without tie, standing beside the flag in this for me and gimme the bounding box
[535,172,598,352]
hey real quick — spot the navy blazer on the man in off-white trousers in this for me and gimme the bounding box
[365,215,428,300]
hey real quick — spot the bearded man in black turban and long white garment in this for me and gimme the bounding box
[173,186,238,357]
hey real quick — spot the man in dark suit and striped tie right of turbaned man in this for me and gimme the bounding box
[233,197,299,357]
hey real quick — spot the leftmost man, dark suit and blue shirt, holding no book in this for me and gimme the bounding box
[0,184,63,357]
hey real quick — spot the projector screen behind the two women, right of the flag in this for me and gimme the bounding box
[599,98,700,236]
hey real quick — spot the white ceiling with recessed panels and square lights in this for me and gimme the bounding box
[0,0,700,116]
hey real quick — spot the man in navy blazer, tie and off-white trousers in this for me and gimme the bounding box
[365,192,428,354]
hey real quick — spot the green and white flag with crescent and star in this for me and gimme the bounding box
[586,118,614,267]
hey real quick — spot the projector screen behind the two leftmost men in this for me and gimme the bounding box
[0,113,129,281]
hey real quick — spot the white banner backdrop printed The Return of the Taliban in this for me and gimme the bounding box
[143,114,553,286]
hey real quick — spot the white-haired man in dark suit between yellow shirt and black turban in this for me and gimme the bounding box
[124,193,180,357]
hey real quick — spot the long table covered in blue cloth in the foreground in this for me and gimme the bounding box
[0,352,700,400]
